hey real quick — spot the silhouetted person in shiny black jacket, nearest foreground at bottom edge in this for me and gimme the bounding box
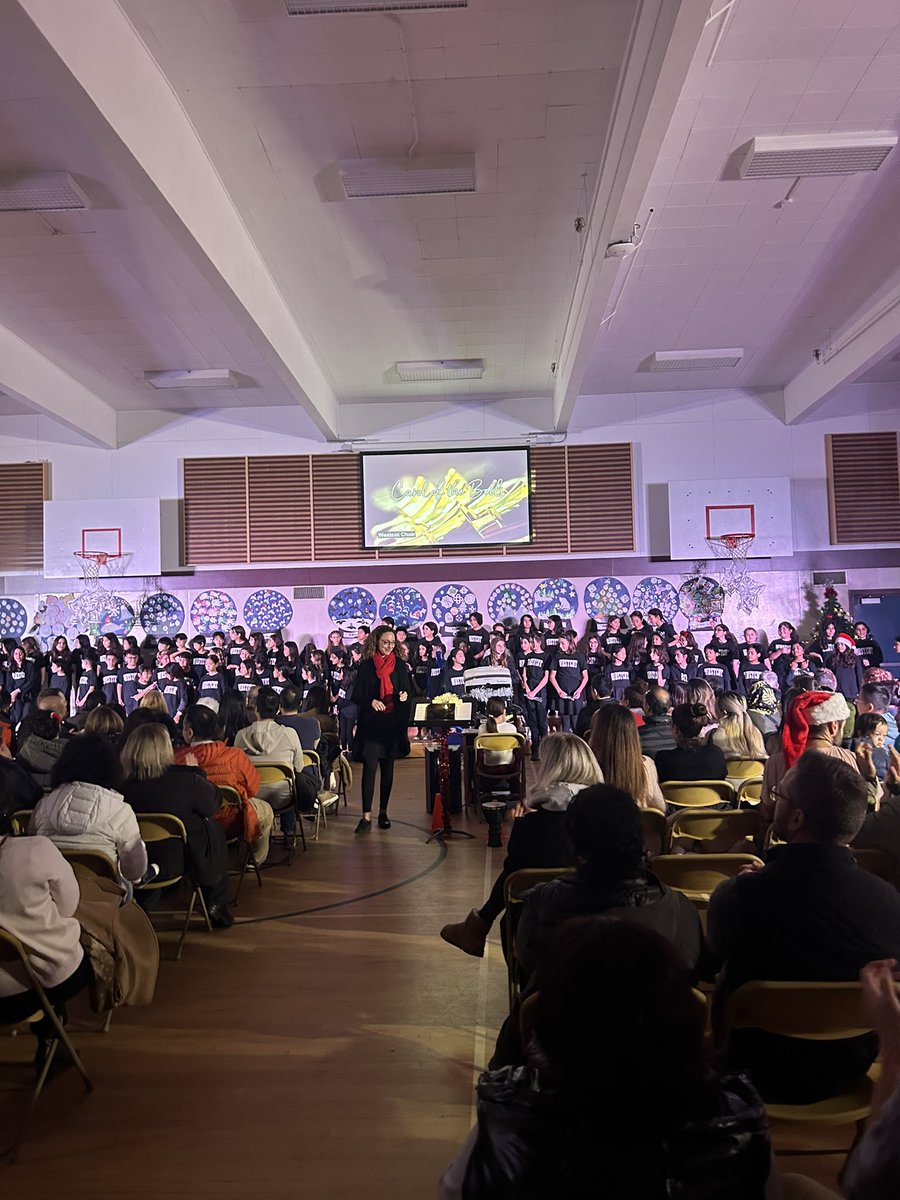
[439,916,772,1200]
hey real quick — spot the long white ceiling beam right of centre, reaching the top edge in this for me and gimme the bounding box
[553,0,709,430]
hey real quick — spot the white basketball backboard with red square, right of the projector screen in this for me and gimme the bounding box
[668,478,793,560]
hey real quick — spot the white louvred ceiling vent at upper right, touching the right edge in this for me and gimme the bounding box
[738,133,896,179]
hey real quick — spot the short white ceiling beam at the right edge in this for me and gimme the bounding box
[785,284,900,425]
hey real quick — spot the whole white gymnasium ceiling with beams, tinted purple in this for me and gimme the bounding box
[0,0,900,446]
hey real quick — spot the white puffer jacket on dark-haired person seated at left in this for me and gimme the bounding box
[28,784,146,882]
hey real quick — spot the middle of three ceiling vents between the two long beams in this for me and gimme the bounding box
[320,154,475,200]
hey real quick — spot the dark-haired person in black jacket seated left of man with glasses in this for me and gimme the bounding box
[516,784,703,980]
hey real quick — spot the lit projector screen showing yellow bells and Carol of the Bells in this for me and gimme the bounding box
[361,449,532,550]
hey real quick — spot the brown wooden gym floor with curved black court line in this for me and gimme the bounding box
[0,758,848,1200]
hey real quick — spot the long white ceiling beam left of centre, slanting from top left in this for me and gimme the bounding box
[18,0,337,437]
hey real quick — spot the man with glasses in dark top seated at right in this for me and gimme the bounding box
[708,750,900,1104]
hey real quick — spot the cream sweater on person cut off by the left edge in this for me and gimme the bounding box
[0,838,82,996]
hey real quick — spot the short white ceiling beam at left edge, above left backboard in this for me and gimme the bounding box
[0,325,119,450]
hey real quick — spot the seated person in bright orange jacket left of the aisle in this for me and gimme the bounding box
[175,692,275,863]
